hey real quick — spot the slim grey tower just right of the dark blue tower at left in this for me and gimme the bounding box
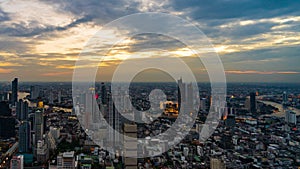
[34,108,44,144]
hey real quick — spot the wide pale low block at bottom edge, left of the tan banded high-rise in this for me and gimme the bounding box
[57,151,75,169]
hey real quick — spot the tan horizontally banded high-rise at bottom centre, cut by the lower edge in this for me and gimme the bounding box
[123,124,138,168]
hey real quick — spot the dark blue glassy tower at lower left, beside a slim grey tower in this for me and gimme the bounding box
[19,121,31,153]
